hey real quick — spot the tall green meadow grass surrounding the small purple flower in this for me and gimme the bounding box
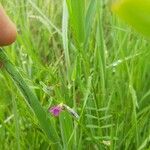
[0,0,150,150]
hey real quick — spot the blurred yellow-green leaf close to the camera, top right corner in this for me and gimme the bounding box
[112,0,150,37]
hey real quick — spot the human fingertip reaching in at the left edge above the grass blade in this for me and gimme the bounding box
[0,5,17,46]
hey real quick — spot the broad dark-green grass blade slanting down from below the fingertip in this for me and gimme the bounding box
[0,48,61,149]
